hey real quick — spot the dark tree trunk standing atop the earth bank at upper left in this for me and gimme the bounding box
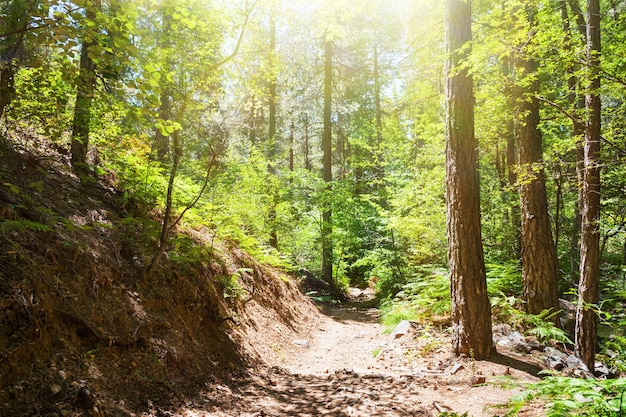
[70,0,101,171]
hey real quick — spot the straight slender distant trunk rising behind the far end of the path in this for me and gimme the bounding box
[322,39,335,288]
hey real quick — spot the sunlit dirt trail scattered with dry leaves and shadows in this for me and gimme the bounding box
[166,290,543,417]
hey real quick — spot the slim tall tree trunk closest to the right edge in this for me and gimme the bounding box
[575,0,602,372]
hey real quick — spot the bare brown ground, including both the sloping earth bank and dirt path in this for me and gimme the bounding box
[0,134,545,417]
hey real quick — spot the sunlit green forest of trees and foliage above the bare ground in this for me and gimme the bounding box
[0,0,626,416]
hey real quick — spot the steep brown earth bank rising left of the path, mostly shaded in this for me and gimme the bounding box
[0,134,317,416]
